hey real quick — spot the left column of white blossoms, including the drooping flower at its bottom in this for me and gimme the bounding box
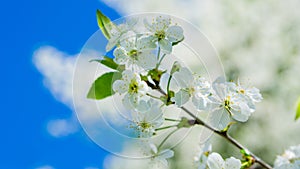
[106,16,184,165]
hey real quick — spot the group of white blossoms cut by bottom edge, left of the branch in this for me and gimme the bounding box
[195,143,242,169]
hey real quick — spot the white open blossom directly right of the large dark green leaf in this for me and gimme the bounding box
[113,70,150,110]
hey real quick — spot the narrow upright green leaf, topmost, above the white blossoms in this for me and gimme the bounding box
[96,9,113,39]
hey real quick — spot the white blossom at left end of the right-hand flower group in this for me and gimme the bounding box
[171,67,210,110]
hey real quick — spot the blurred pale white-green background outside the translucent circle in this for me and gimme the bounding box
[101,0,300,169]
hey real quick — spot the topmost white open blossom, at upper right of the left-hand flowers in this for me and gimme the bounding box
[144,16,183,54]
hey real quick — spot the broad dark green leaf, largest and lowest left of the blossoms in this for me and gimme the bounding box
[87,72,122,100]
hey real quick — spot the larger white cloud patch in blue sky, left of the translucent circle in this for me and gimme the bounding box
[33,46,76,106]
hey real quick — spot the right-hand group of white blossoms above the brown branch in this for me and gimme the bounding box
[171,64,262,130]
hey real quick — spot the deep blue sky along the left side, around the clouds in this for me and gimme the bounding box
[0,0,119,169]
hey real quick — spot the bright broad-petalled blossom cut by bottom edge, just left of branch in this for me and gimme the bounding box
[207,153,242,169]
